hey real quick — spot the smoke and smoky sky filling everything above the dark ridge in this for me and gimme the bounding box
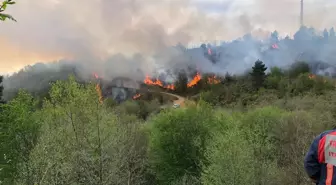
[0,0,336,99]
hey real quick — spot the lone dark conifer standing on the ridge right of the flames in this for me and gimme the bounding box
[250,60,267,89]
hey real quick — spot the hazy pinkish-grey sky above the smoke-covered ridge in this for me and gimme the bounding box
[0,0,336,74]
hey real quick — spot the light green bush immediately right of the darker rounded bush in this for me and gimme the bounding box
[202,107,287,185]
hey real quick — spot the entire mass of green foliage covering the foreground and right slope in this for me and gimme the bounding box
[0,61,336,185]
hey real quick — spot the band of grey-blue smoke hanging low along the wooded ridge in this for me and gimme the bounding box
[4,24,336,98]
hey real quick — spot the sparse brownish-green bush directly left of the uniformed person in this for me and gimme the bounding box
[273,111,330,185]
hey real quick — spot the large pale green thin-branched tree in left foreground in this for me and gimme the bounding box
[21,77,146,185]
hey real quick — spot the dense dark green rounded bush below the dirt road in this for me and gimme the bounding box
[149,103,218,184]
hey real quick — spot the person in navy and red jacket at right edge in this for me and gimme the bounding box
[304,129,336,185]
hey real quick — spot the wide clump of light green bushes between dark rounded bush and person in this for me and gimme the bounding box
[202,107,328,185]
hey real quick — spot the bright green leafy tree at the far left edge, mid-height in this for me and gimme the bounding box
[0,91,40,184]
